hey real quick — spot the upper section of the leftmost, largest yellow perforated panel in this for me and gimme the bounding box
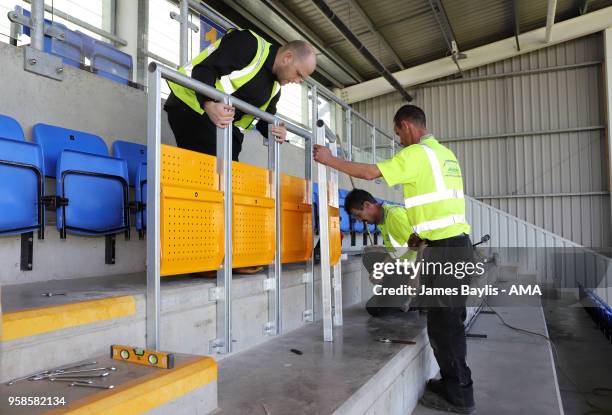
[161,144,219,190]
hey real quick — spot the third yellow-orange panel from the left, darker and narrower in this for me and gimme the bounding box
[281,174,312,264]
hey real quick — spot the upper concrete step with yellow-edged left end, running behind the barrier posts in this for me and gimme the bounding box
[0,260,368,381]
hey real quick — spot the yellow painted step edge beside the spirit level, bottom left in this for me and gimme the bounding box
[46,356,217,415]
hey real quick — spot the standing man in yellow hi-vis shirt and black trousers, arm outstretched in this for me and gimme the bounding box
[313,105,475,413]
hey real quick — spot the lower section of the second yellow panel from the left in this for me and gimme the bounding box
[232,194,275,268]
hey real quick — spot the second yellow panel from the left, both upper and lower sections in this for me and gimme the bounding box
[232,161,276,268]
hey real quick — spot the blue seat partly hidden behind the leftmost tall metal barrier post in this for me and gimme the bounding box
[113,140,147,236]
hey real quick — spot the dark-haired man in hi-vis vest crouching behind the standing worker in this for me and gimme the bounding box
[344,189,419,317]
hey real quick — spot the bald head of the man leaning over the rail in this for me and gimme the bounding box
[272,40,317,85]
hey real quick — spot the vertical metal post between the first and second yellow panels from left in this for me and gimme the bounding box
[214,96,234,354]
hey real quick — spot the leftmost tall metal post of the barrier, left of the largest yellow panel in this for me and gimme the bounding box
[146,69,161,350]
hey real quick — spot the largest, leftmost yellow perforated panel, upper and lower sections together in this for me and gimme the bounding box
[160,145,224,276]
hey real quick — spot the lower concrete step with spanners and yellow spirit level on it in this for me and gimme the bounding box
[0,354,217,415]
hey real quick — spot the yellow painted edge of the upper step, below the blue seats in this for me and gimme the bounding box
[1,295,136,341]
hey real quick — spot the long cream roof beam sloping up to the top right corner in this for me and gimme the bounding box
[339,6,612,103]
